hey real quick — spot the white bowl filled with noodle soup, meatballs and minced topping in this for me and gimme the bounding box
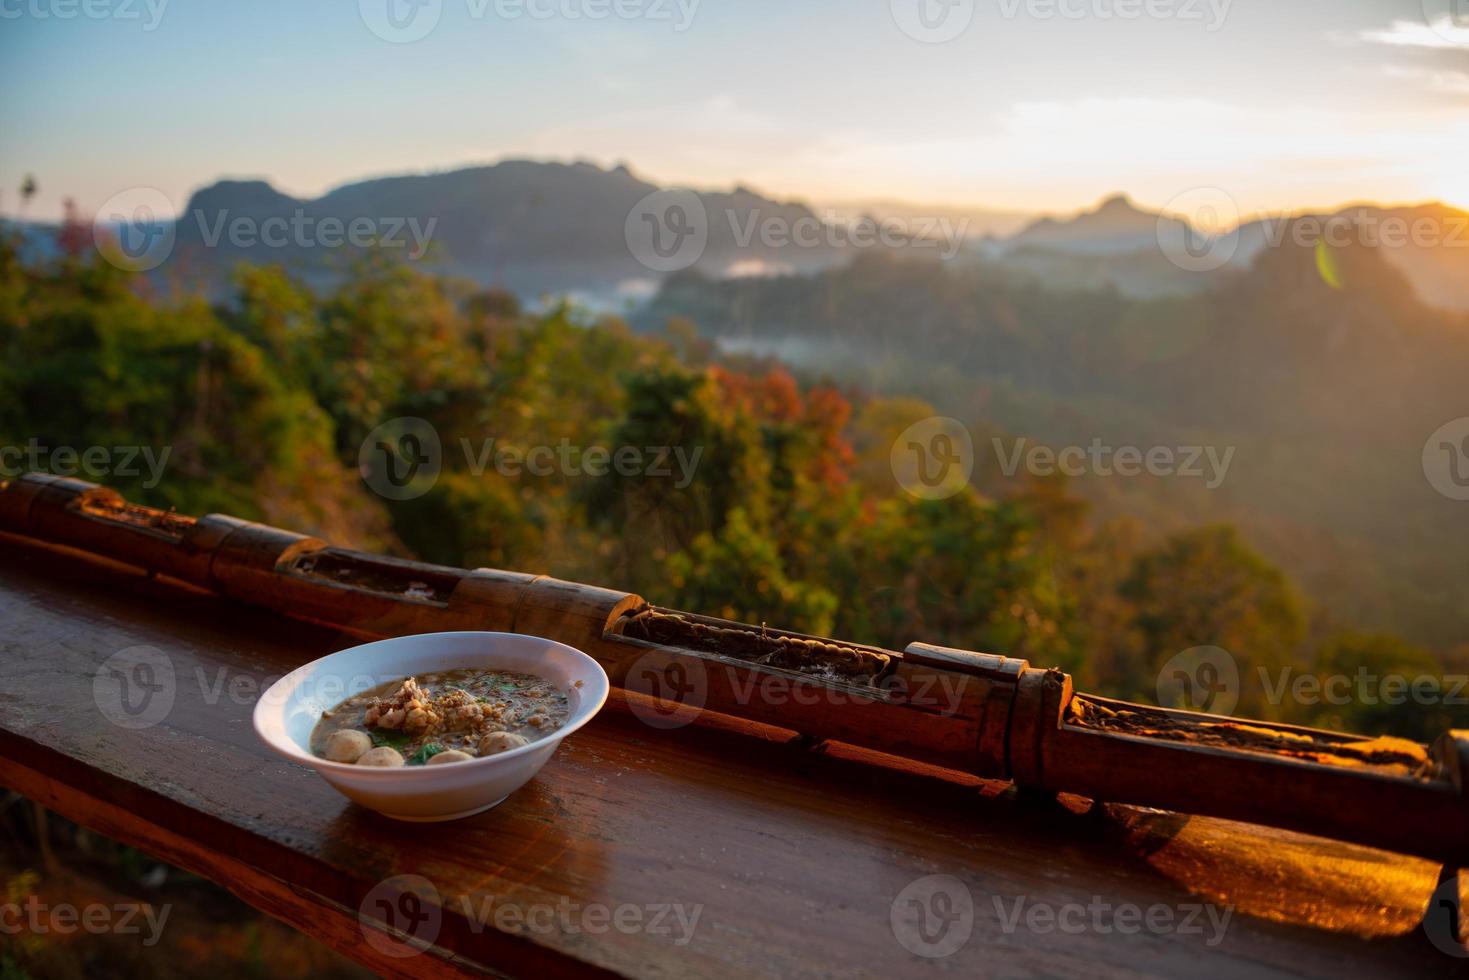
[254,632,610,821]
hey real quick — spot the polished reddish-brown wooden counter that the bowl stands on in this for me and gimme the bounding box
[0,536,1466,977]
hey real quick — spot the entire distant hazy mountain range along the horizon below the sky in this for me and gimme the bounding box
[11,160,1469,310]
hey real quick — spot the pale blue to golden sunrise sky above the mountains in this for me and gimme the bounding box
[0,0,1469,219]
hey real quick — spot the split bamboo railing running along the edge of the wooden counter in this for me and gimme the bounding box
[0,475,1469,867]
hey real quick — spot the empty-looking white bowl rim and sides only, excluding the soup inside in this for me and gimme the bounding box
[254,633,610,821]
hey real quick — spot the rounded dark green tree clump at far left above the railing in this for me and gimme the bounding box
[0,238,349,528]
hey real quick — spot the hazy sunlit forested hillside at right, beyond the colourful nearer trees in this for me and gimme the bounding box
[639,235,1469,646]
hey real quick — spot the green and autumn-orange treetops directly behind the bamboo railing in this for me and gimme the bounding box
[0,226,1465,735]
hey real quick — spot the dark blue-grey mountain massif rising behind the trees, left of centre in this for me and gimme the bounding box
[176,160,857,298]
